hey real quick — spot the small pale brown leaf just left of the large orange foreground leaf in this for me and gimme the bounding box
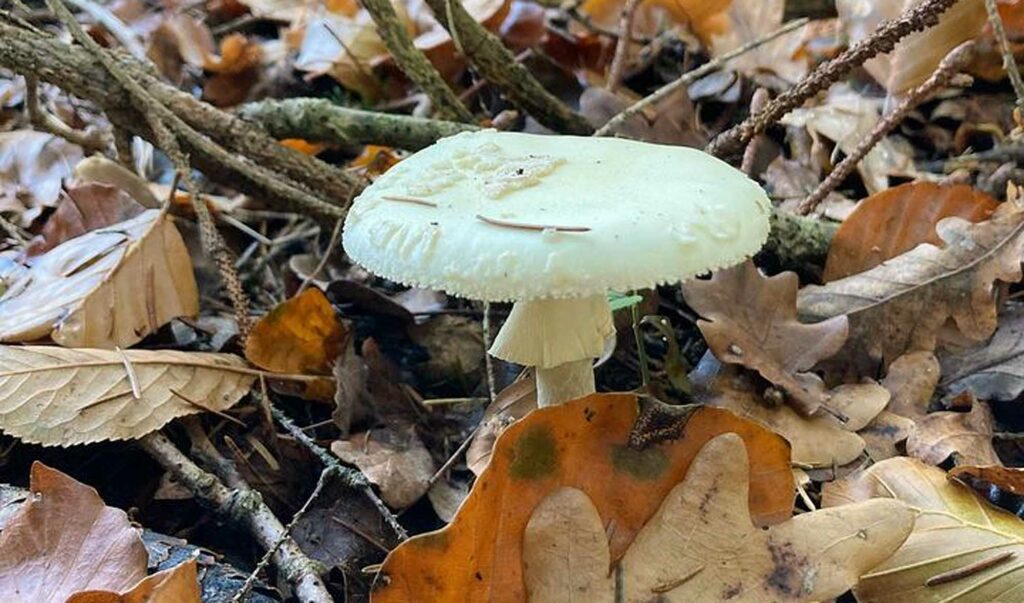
[331,425,436,509]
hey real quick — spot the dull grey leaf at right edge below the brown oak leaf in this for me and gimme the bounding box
[940,305,1024,400]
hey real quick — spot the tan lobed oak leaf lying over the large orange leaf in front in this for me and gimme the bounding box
[523,434,913,603]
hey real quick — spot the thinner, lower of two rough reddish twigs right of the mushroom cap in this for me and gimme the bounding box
[797,41,974,215]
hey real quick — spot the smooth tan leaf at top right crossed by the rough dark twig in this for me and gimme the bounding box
[836,0,986,93]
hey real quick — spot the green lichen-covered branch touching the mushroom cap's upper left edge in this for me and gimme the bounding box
[239,98,478,150]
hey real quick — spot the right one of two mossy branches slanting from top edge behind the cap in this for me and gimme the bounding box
[419,0,594,134]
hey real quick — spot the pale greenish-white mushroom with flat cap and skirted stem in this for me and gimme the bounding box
[343,130,770,406]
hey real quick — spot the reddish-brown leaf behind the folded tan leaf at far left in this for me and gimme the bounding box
[28,183,145,256]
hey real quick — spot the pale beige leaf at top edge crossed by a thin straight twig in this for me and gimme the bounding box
[711,0,808,84]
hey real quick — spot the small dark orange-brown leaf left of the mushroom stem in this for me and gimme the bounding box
[246,287,351,375]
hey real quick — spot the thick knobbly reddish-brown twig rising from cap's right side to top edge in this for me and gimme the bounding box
[706,0,957,157]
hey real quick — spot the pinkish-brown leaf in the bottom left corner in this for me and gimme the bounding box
[0,460,148,603]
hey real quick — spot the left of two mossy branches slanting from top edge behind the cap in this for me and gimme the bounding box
[360,0,473,123]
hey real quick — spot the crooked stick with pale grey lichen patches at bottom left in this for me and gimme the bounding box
[138,432,332,603]
